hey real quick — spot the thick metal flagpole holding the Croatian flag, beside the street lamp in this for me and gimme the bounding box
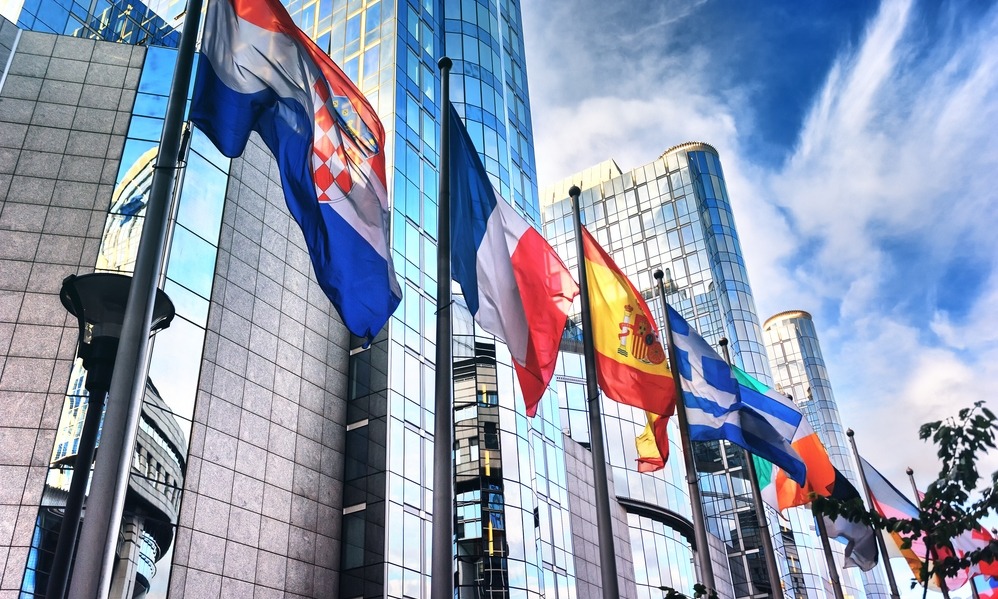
[69,0,203,599]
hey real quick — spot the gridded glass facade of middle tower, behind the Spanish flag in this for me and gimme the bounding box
[544,143,782,597]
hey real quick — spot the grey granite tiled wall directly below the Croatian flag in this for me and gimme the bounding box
[169,136,349,597]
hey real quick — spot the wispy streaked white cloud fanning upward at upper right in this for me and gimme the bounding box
[769,1,998,284]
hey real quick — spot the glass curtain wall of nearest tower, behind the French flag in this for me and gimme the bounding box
[320,0,573,597]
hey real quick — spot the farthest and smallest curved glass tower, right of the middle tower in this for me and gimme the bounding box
[763,310,889,597]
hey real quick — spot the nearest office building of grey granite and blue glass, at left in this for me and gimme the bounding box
[0,0,616,597]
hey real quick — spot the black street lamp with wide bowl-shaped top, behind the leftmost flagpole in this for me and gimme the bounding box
[45,273,175,599]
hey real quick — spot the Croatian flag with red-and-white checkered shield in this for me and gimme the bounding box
[190,0,402,339]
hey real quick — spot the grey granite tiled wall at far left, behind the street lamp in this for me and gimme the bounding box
[0,27,145,597]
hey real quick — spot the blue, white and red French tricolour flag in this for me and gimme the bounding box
[447,106,579,416]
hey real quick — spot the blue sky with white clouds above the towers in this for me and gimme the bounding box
[523,0,998,548]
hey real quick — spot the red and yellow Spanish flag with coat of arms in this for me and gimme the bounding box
[581,227,676,471]
